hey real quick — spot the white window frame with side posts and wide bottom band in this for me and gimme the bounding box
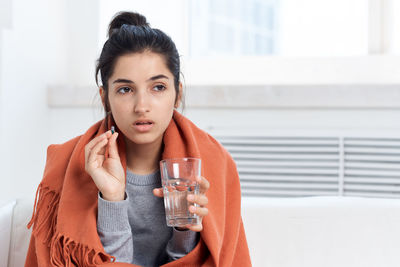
[182,0,400,86]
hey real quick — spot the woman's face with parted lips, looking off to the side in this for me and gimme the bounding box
[102,51,179,149]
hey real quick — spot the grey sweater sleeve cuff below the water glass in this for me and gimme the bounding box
[166,227,200,261]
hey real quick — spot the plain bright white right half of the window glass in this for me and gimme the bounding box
[278,0,369,57]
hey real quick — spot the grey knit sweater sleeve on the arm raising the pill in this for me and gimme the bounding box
[97,193,133,263]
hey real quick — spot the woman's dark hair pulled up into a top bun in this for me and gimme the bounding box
[96,11,180,126]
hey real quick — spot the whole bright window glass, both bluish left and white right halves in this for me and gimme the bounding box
[189,0,368,57]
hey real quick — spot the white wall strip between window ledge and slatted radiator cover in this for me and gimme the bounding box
[185,107,400,137]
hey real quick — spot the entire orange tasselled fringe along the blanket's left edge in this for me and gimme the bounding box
[27,184,115,267]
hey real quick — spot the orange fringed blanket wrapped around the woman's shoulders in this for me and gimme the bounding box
[25,111,251,267]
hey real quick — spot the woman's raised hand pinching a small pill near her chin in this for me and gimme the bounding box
[85,131,125,201]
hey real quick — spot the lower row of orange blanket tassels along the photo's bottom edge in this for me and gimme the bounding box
[50,234,115,267]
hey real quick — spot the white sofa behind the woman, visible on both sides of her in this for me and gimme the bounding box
[0,197,400,267]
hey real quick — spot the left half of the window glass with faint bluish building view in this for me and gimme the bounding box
[189,0,278,57]
